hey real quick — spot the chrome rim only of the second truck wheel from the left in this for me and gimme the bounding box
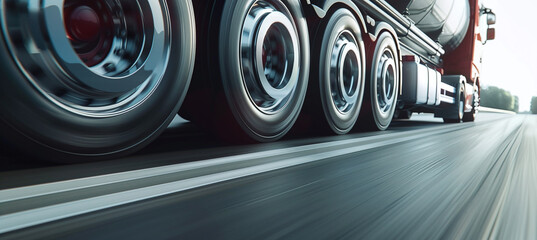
[240,0,301,114]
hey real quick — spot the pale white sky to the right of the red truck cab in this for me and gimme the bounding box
[481,0,537,112]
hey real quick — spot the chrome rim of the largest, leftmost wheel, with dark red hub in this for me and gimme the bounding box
[2,0,171,118]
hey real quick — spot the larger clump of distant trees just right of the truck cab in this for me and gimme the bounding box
[480,86,516,112]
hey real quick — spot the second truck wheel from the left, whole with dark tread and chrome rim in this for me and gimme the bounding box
[185,0,309,142]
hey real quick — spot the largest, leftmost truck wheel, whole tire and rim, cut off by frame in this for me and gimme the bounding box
[0,0,195,162]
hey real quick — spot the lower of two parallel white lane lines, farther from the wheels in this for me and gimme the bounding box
[0,133,436,234]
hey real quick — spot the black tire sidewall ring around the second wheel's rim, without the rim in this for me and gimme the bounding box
[219,0,309,141]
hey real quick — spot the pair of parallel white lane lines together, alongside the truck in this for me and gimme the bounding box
[0,122,468,233]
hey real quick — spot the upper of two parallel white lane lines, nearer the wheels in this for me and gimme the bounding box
[0,125,464,203]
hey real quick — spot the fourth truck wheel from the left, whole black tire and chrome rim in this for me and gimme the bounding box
[358,31,401,130]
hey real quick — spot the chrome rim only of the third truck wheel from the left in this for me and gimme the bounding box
[330,30,362,114]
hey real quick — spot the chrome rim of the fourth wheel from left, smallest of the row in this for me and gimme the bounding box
[376,48,397,115]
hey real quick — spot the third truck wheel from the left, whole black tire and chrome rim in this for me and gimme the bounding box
[312,9,366,134]
